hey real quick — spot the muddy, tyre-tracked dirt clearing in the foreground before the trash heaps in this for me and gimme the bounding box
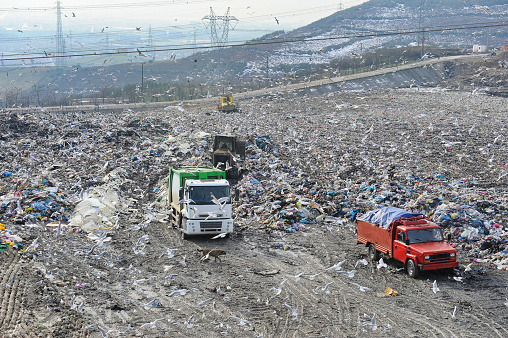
[0,218,508,337]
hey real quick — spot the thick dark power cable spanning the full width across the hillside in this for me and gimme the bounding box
[0,21,508,61]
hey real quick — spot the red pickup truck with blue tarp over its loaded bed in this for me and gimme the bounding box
[356,207,458,278]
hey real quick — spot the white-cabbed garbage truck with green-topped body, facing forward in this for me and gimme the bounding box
[168,166,233,238]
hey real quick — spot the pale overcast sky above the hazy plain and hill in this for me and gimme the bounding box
[0,0,365,35]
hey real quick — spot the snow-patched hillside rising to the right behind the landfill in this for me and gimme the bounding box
[0,0,508,106]
